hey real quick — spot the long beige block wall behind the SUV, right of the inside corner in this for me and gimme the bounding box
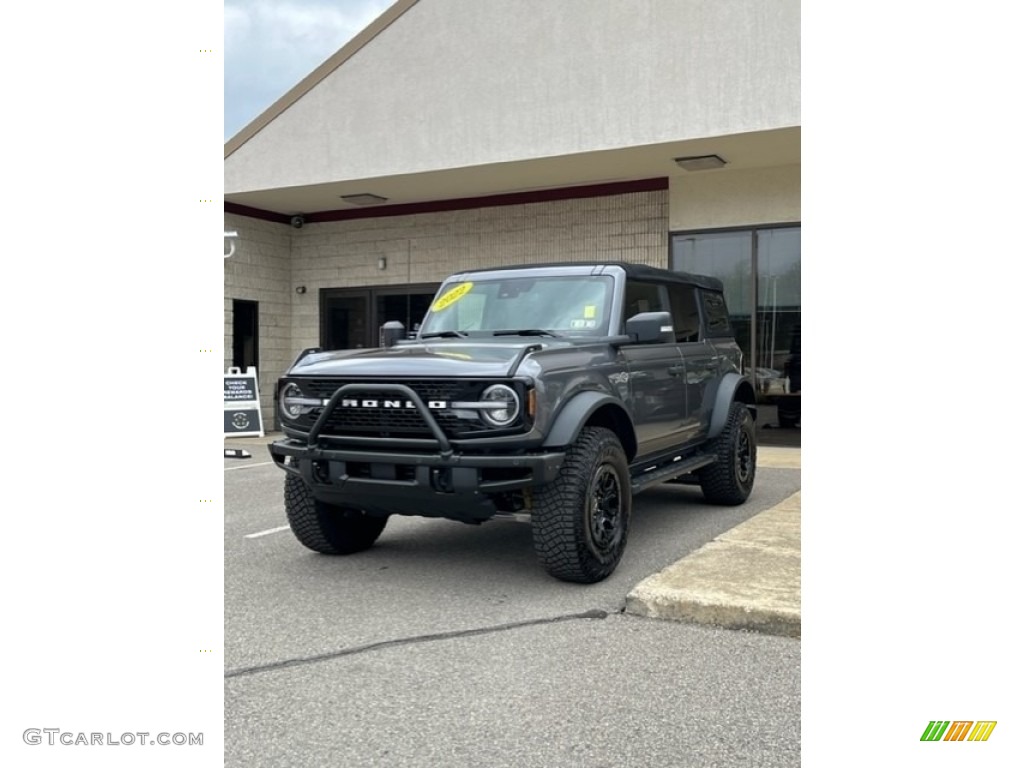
[290,189,669,351]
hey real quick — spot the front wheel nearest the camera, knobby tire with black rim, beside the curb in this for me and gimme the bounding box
[532,427,633,584]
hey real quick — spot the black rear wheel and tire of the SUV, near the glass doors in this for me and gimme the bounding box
[697,402,758,507]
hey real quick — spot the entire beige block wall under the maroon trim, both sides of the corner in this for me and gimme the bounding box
[224,189,669,431]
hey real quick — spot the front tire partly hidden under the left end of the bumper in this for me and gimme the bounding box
[285,474,387,555]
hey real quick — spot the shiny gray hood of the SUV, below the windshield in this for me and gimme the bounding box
[289,338,551,378]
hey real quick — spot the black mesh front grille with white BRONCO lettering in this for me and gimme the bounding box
[298,379,507,439]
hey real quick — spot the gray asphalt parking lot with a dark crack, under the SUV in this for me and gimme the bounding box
[224,441,800,766]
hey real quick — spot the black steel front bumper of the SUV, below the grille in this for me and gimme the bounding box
[268,439,565,519]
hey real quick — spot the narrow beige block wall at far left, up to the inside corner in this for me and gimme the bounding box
[224,214,294,431]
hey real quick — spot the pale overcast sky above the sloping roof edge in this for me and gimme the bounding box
[224,0,394,141]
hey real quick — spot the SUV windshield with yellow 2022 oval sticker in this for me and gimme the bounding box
[420,274,612,338]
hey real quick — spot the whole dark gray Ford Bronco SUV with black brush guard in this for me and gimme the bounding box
[269,263,757,583]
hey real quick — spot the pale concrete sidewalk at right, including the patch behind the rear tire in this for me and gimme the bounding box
[626,446,800,637]
